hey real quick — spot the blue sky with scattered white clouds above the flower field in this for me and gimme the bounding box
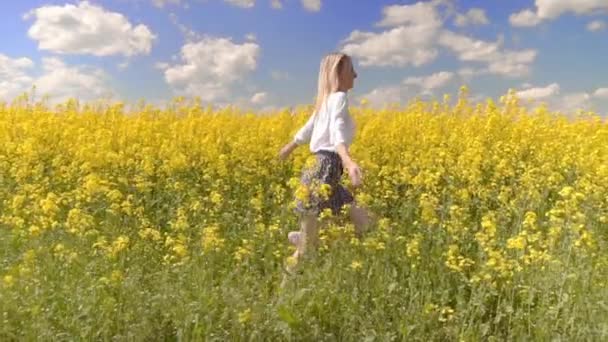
[0,0,608,115]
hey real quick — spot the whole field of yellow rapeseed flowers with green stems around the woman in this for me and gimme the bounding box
[0,88,608,341]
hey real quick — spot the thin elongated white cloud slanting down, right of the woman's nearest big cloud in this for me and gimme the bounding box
[439,30,537,77]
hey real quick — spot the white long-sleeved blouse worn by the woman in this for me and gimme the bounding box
[294,91,355,153]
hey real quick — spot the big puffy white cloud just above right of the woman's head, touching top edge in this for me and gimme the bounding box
[342,1,442,66]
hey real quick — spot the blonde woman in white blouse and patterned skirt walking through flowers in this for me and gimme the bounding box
[279,52,371,270]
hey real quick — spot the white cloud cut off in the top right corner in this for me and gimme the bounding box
[509,0,608,26]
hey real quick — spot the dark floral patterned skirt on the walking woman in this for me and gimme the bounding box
[294,150,354,216]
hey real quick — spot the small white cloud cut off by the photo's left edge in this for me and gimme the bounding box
[0,54,34,101]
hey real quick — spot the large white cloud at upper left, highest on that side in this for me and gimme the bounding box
[24,1,155,56]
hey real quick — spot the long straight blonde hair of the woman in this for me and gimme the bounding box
[314,52,352,112]
